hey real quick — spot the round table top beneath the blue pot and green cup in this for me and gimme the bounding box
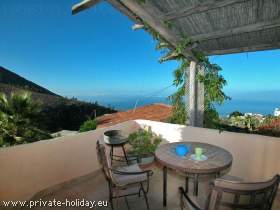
[155,142,233,174]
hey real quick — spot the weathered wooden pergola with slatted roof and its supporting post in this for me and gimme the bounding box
[72,0,280,126]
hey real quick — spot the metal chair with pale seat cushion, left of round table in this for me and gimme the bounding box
[96,141,153,210]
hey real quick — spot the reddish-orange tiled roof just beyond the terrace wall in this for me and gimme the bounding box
[97,104,172,128]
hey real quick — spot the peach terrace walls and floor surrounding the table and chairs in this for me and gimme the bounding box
[0,120,280,210]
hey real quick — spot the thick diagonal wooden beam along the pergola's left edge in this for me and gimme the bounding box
[114,0,198,62]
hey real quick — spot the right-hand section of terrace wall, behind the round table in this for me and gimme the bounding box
[137,120,280,180]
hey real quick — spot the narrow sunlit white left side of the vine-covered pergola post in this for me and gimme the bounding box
[188,61,197,126]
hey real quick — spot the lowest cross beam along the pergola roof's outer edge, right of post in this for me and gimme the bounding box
[204,42,280,56]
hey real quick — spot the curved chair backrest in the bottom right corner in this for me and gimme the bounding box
[208,175,280,210]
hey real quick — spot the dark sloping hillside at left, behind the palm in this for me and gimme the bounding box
[0,67,116,132]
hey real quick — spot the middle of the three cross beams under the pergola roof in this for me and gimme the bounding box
[190,18,280,42]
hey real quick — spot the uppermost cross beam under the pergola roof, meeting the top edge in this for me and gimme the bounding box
[162,0,248,21]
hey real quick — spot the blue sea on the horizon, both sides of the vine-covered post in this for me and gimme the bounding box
[79,96,280,117]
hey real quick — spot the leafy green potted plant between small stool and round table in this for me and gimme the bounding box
[129,127,162,156]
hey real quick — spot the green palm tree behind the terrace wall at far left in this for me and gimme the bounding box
[0,92,51,147]
